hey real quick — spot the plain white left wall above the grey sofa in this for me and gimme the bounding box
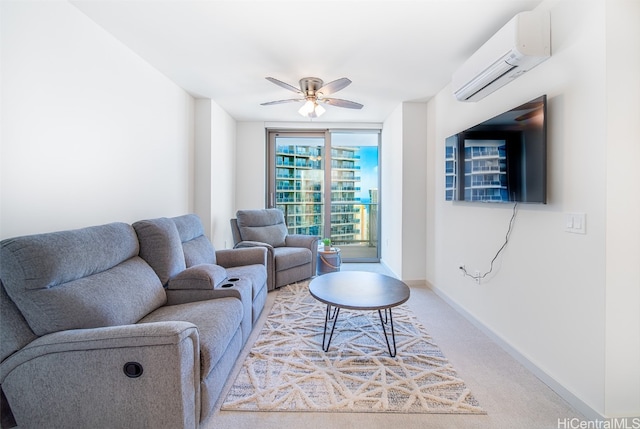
[0,1,193,238]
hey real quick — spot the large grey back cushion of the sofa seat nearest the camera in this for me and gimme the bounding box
[0,223,166,335]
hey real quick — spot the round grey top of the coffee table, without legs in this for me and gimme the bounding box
[309,271,410,310]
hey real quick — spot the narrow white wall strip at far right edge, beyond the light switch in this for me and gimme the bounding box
[605,0,640,416]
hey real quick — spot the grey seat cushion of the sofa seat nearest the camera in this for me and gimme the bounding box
[138,298,243,380]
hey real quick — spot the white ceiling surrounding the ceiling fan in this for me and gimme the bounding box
[71,0,540,122]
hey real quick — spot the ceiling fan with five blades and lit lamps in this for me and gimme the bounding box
[261,77,363,118]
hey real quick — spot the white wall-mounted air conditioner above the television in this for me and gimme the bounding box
[452,11,551,101]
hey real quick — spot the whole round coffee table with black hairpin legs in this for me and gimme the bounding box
[309,271,410,357]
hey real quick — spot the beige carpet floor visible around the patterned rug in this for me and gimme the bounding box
[202,264,584,429]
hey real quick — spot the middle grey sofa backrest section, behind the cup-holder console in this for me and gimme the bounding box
[133,218,186,285]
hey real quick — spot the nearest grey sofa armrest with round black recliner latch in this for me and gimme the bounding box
[0,322,200,427]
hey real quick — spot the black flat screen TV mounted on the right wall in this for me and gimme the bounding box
[445,95,547,204]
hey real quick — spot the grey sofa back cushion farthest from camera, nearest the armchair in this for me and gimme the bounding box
[171,214,216,268]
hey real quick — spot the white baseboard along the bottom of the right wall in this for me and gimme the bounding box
[424,281,606,421]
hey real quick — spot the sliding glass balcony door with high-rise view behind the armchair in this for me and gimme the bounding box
[268,131,380,262]
